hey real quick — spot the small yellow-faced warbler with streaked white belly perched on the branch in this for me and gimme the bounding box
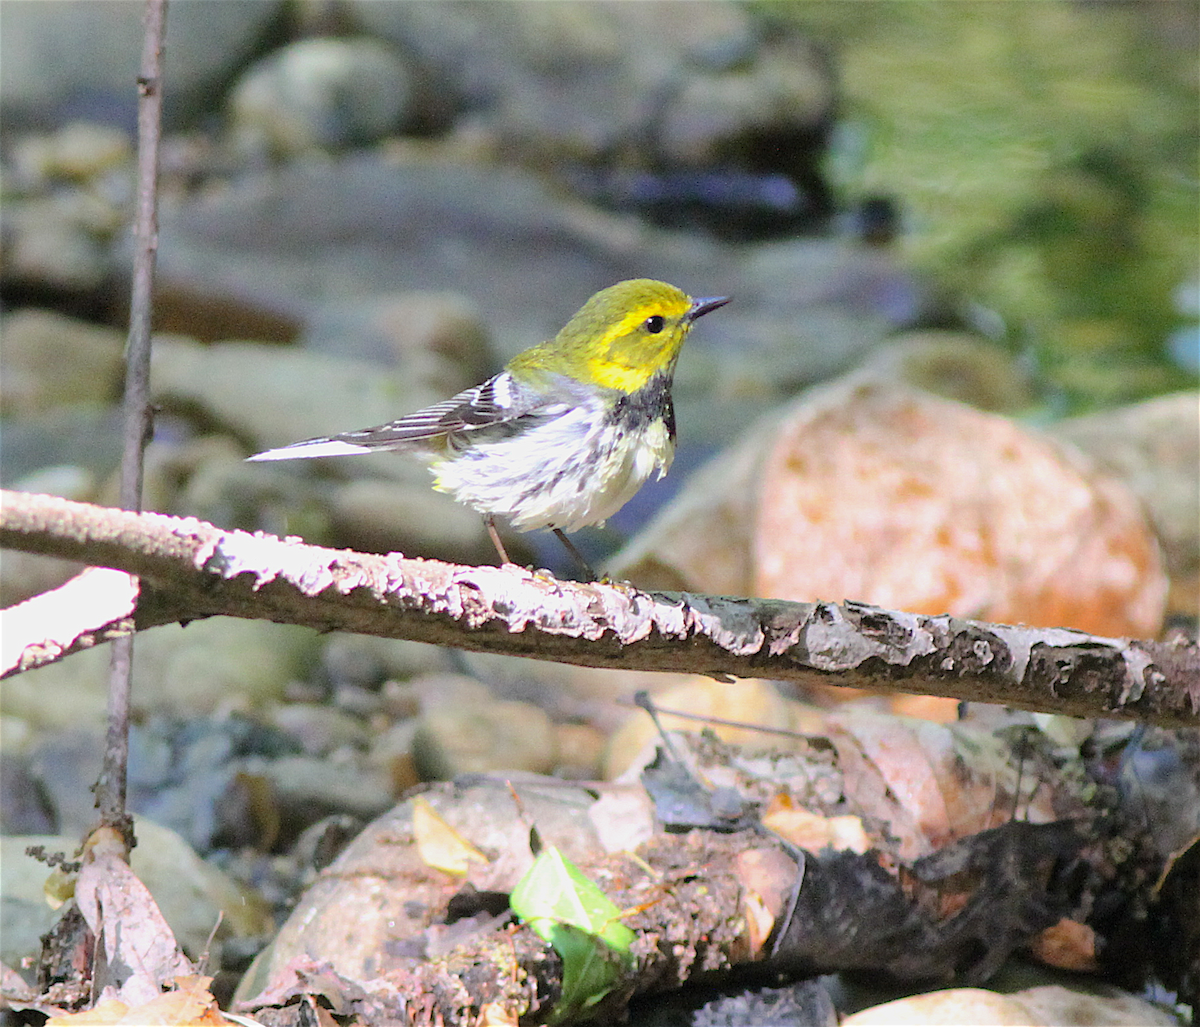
[250,278,728,566]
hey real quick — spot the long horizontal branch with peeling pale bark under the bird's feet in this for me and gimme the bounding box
[0,492,1200,726]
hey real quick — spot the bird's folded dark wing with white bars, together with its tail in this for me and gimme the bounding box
[248,371,564,461]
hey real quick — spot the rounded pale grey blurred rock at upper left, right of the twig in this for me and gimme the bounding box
[229,37,412,155]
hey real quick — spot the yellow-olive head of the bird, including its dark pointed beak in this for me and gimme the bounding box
[509,278,728,392]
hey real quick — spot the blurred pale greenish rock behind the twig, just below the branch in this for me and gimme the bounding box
[0,617,316,728]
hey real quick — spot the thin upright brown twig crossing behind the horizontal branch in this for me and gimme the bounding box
[95,0,167,845]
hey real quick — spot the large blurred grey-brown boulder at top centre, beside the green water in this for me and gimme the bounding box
[348,0,834,167]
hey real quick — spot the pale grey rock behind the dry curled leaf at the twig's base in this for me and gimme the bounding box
[0,817,272,967]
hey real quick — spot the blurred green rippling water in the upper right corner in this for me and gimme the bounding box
[755,0,1200,410]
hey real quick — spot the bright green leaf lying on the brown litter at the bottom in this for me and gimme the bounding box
[509,847,636,1022]
